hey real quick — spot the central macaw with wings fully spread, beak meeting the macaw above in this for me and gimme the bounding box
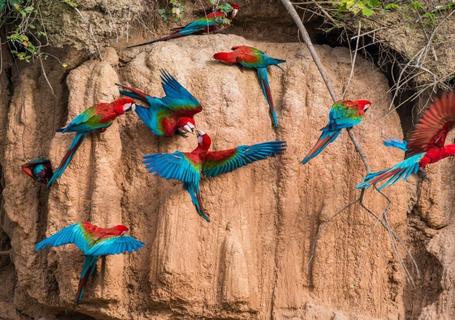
[144,130,286,222]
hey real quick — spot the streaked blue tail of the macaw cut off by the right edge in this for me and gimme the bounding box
[356,153,425,190]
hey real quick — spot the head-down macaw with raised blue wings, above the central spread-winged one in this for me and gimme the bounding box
[119,70,202,137]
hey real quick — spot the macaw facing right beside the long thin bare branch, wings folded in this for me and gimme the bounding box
[302,100,371,164]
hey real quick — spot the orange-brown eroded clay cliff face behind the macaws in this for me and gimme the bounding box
[0,4,455,320]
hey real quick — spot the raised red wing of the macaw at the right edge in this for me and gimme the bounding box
[409,92,455,154]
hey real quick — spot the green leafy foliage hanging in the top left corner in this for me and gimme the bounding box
[0,0,77,62]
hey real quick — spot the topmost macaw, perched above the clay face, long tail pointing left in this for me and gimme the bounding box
[127,3,240,48]
